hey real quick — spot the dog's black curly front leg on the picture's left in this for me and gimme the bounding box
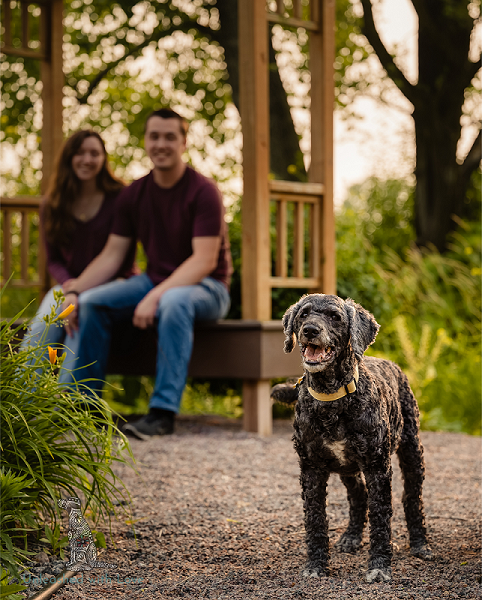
[300,462,329,577]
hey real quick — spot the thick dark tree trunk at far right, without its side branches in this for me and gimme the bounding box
[413,0,480,252]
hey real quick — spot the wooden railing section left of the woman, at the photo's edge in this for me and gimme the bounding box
[0,196,50,293]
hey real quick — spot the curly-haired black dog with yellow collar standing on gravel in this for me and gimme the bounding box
[271,294,432,582]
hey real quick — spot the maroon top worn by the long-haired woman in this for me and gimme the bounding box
[40,192,136,284]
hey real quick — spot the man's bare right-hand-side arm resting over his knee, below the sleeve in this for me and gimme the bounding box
[132,236,221,329]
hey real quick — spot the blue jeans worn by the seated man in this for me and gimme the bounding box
[67,274,230,413]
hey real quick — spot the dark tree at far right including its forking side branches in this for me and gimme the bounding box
[361,0,482,250]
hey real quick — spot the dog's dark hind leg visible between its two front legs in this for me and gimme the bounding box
[335,473,368,553]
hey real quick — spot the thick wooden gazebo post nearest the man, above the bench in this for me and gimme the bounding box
[238,0,271,321]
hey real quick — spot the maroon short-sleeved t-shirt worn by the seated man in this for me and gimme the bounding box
[112,167,232,287]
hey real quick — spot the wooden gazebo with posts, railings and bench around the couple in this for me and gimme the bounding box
[2,0,336,435]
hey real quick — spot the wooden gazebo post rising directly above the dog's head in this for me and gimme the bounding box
[309,0,336,294]
